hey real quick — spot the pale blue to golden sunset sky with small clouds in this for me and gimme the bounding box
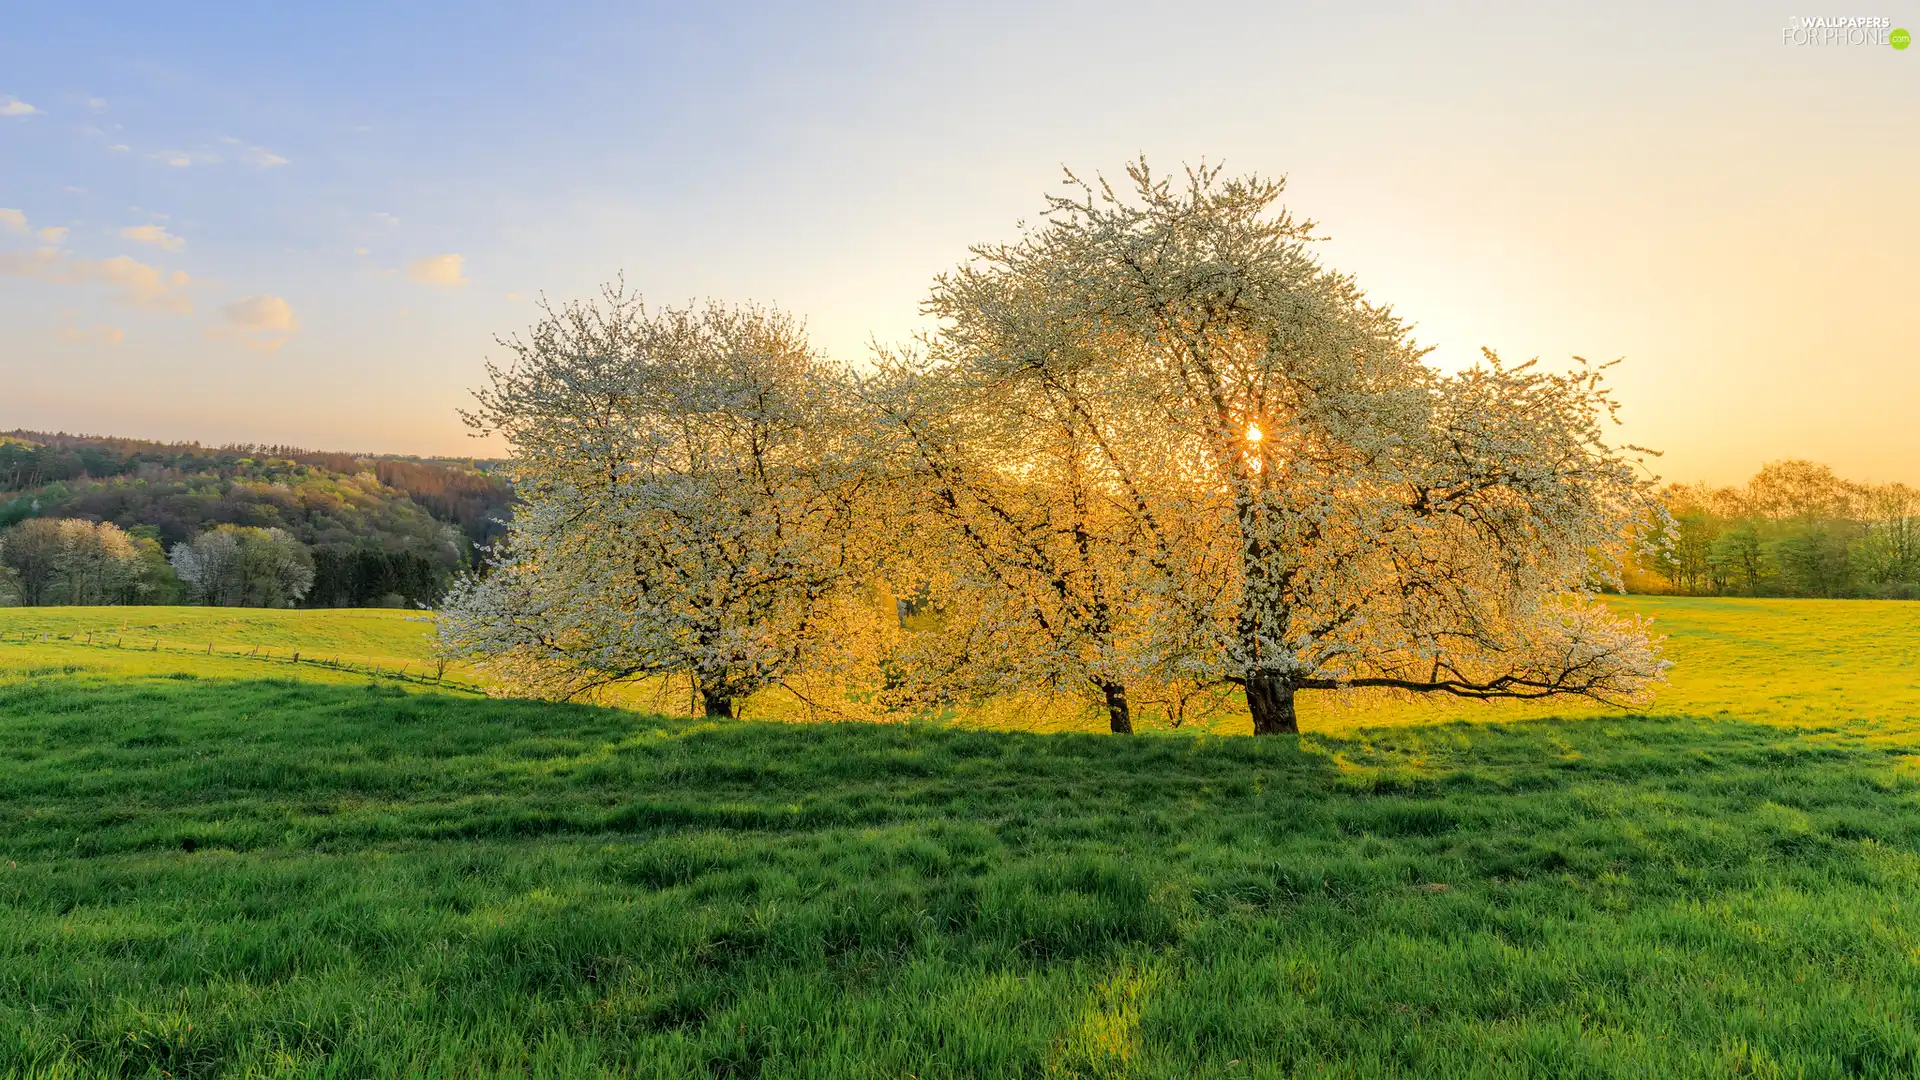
[0,0,1920,482]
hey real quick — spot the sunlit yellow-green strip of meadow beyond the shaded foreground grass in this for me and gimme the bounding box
[0,596,1920,734]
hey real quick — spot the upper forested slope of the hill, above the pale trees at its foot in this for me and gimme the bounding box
[0,430,513,603]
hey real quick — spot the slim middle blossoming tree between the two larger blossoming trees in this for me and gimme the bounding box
[866,342,1156,734]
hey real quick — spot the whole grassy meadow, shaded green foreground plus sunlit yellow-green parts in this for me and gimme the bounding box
[0,600,1920,1080]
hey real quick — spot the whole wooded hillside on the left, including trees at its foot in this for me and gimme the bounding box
[0,430,513,607]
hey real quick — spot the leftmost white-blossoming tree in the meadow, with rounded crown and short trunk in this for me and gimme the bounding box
[440,286,885,717]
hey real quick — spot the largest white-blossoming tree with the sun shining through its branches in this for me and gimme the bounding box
[929,161,1665,734]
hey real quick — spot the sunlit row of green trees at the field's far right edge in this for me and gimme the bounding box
[1626,461,1920,600]
